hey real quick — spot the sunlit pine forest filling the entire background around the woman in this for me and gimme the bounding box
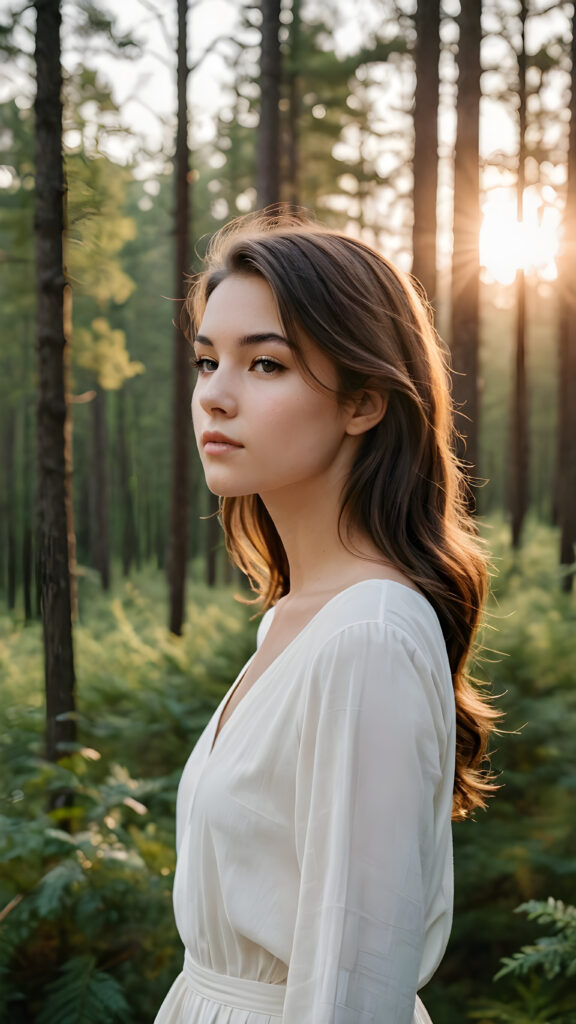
[0,0,576,1024]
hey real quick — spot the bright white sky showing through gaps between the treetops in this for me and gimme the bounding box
[0,0,567,281]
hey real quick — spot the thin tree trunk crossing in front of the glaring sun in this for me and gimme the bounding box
[508,0,529,550]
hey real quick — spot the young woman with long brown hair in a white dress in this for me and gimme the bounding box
[156,216,495,1024]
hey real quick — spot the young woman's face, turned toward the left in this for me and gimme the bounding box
[192,274,359,501]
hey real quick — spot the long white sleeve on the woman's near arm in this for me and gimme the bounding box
[283,622,454,1024]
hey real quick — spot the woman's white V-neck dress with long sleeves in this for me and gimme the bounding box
[155,580,455,1024]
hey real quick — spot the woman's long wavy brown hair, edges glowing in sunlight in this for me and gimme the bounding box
[184,211,498,818]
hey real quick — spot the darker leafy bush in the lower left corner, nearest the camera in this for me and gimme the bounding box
[0,759,176,1022]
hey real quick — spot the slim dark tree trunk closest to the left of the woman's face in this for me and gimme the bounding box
[168,0,191,636]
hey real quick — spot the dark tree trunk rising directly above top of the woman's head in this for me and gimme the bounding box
[256,0,281,209]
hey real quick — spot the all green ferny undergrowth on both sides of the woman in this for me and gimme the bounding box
[0,532,576,1024]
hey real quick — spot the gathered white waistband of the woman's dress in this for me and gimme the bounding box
[183,951,286,1017]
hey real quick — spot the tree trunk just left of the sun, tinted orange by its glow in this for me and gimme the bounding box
[452,0,482,506]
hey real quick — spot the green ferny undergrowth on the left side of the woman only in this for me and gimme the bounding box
[0,574,255,1024]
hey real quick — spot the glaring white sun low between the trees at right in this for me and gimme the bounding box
[480,185,561,285]
